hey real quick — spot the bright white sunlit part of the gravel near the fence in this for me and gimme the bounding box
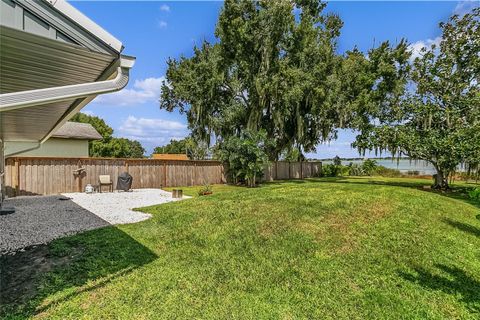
[63,189,187,224]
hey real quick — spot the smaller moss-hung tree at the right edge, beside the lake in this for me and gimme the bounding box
[355,8,480,189]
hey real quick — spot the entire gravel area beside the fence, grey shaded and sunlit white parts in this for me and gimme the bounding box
[0,189,188,255]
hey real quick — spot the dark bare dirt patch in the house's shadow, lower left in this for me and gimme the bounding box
[0,245,82,305]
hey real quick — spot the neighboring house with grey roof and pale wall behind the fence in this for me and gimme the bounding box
[5,121,102,158]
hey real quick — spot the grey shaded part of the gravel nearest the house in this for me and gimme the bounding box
[0,196,110,254]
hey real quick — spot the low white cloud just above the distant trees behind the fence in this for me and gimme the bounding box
[117,116,189,151]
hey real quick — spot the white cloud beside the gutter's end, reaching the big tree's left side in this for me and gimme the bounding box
[94,77,165,106]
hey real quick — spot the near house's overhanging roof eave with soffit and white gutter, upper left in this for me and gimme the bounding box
[0,0,135,212]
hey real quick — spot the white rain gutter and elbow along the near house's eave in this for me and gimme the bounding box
[0,56,135,112]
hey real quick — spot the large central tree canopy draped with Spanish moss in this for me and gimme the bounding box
[161,0,343,159]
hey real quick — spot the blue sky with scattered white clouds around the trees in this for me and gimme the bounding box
[70,1,480,159]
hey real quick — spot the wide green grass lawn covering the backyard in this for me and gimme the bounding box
[3,178,480,319]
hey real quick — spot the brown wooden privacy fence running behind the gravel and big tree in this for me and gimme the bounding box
[5,157,321,197]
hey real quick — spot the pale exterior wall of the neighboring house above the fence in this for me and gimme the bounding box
[5,138,88,158]
